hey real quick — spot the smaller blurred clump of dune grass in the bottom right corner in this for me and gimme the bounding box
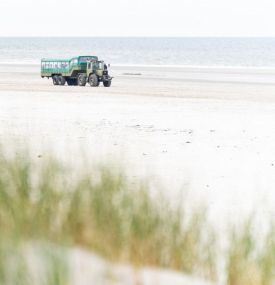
[226,218,275,285]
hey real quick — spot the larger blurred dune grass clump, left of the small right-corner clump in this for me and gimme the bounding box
[0,153,215,285]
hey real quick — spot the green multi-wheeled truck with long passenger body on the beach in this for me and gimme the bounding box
[41,56,112,87]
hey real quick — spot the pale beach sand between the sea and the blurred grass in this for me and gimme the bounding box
[0,64,275,223]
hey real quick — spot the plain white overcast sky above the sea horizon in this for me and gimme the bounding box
[0,0,275,36]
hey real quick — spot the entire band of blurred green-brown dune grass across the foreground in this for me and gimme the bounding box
[0,152,275,285]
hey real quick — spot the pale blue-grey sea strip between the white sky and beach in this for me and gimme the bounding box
[0,37,275,68]
